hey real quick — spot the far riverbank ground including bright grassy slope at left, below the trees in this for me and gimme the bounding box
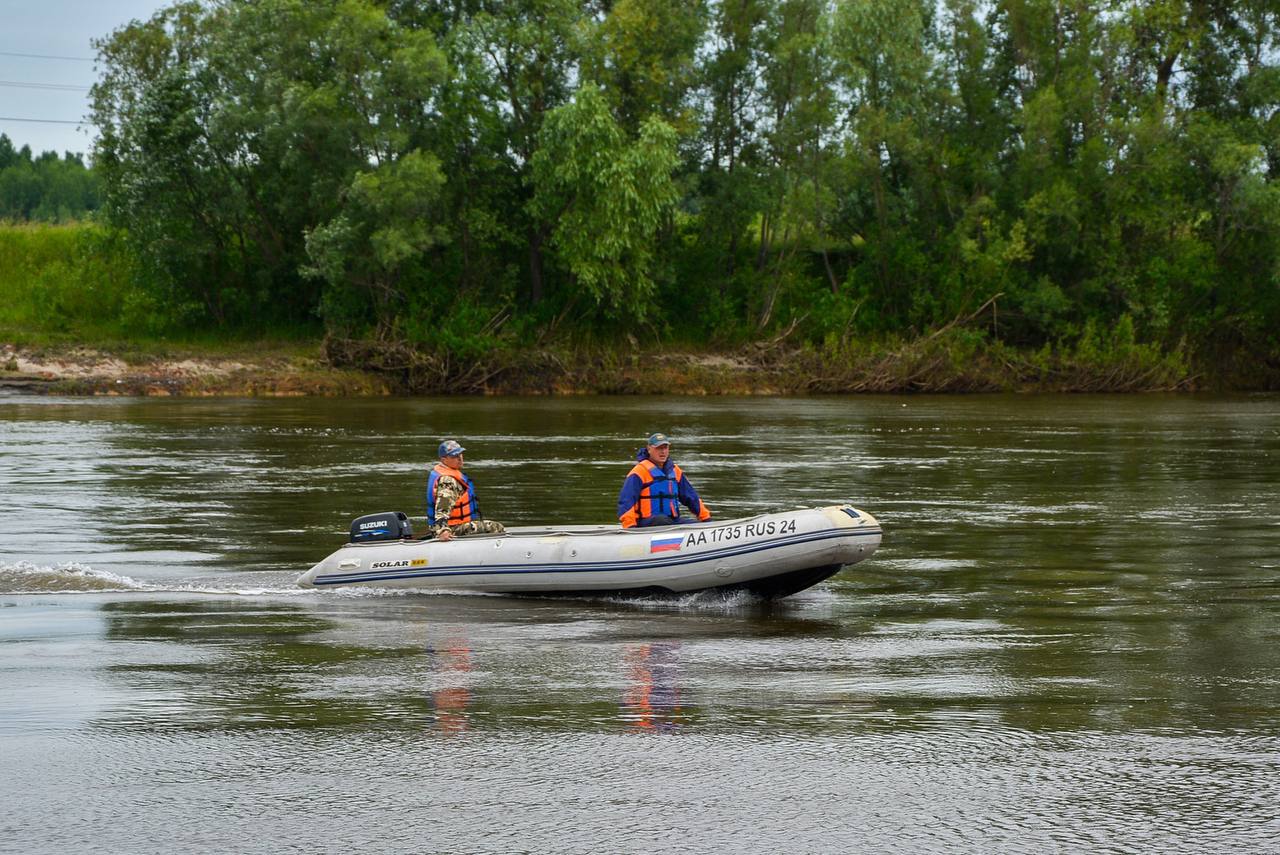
[0,223,1264,397]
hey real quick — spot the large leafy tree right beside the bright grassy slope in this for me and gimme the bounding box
[93,0,444,323]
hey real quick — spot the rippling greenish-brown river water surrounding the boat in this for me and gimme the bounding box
[0,396,1280,854]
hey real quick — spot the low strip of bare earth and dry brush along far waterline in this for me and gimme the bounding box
[0,339,1208,397]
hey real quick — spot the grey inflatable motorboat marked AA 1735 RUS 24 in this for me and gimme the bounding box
[298,506,881,599]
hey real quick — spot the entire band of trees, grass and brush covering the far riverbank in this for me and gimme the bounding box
[0,0,1280,394]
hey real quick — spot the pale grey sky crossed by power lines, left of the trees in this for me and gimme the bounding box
[0,0,169,155]
